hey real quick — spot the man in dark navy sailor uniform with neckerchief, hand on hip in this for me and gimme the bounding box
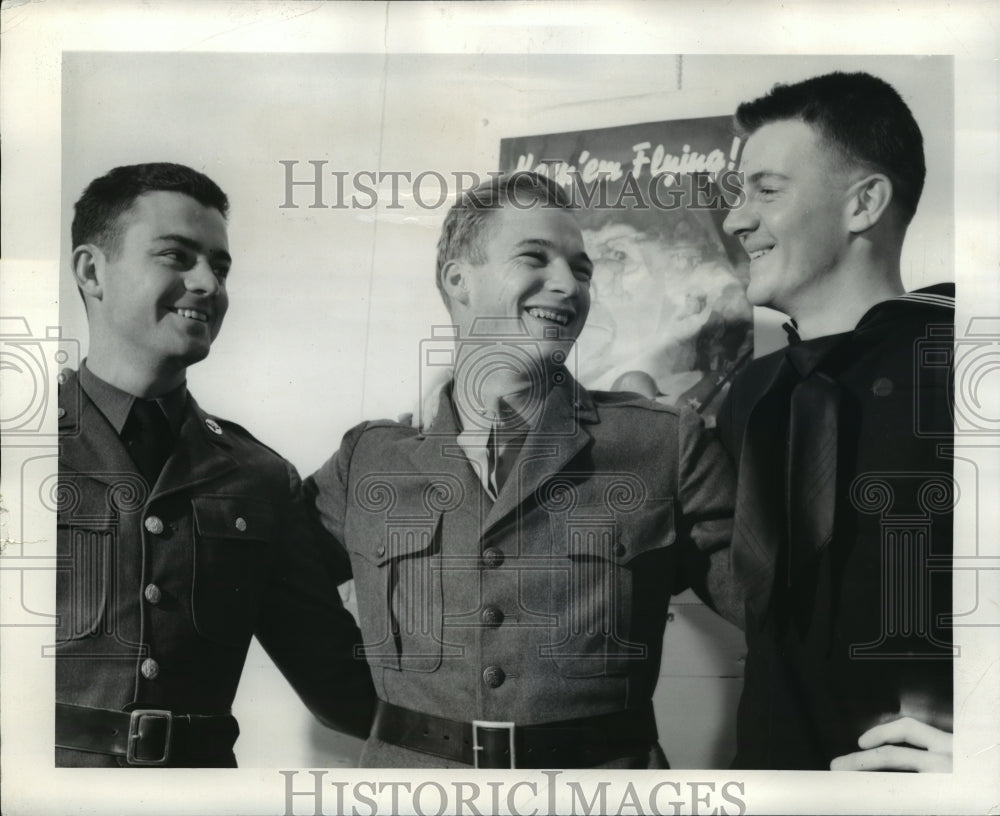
[718,73,954,770]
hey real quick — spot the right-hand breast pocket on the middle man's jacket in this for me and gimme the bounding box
[542,499,675,677]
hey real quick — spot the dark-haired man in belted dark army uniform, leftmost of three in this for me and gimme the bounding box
[56,163,372,767]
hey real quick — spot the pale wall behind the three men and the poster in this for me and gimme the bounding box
[60,52,954,767]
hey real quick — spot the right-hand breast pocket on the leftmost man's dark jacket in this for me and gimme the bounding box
[191,496,279,646]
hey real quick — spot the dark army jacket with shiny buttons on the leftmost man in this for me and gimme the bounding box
[56,372,371,766]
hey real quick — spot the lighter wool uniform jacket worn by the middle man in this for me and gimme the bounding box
[306,376,732,767]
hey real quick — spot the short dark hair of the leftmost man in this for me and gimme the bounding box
[71,162,229,255]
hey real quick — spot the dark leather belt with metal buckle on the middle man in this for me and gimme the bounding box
[372,700,657,768]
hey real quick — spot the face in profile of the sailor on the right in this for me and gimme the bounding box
[723,119,853,317]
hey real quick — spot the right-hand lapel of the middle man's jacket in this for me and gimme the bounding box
[483,372,599,535]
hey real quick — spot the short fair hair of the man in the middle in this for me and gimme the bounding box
[436,170,574,308]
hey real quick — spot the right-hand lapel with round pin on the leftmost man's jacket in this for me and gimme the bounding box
[150,394,239,498]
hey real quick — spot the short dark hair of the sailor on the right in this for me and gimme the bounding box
[735,71,926,224]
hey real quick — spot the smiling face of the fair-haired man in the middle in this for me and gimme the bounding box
[456,204,593,364]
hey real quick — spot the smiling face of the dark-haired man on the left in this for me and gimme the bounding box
[88,191,232,380]
